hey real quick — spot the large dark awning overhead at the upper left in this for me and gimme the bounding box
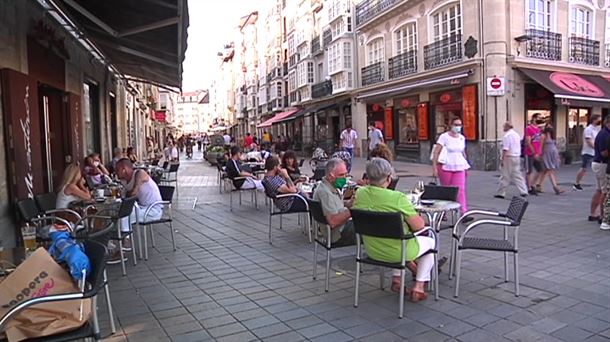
[46,0,189,87]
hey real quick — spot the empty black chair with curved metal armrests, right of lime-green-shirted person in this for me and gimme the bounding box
[449,196,528,297]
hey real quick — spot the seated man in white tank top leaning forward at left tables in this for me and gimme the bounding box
[116,158,163,232]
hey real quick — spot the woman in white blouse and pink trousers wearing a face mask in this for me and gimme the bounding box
[432,117,470,213]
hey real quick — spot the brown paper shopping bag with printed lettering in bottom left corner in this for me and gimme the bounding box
[0,248,91,342]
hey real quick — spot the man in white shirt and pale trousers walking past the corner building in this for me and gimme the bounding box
[494,122,527,198]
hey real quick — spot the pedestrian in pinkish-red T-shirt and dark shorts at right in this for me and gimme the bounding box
[524,113,544,195]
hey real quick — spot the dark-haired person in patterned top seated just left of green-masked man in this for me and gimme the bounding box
[263,157,307,212]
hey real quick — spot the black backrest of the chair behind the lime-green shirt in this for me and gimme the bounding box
[351,209,404,239]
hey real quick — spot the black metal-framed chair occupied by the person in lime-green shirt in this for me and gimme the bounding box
[351,209,438,318]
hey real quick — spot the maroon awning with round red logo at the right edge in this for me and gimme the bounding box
[519,68,610,105]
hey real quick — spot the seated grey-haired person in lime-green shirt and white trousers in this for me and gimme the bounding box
[353,158,435,302]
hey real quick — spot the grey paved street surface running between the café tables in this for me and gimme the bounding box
[99,152,610,341]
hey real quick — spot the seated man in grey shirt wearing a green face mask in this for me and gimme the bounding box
[313,158,356,245]
